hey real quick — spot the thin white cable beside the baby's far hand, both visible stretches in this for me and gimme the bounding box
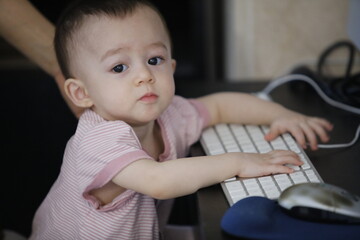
[259,74,360,148]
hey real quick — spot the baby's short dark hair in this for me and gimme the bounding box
[54,0,170,79]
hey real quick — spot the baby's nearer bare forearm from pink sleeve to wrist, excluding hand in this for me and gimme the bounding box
[113,154,239,199]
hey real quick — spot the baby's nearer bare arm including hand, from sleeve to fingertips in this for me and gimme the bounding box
[112,150,302,199]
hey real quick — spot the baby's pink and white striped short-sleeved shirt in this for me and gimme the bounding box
[30,96,209,240]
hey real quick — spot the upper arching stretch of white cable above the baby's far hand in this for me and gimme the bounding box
[261,74,360,114]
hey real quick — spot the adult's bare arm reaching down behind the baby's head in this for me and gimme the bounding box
[0,0,82,117]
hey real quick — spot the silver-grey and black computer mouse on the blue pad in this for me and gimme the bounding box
[278,183,360,223]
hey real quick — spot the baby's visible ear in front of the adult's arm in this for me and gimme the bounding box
[64,78,93,108]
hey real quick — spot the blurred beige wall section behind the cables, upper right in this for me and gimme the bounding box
[224,0,348,80]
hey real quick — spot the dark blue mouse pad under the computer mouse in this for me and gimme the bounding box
[221,197,360,240]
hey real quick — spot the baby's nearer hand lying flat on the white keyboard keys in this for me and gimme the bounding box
[238,150,303,177]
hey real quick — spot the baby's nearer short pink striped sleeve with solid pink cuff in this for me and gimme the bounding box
[77,121,151,201]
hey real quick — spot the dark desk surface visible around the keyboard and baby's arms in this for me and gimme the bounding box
[179,82,360,239]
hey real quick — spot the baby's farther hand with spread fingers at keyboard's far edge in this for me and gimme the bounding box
[265,113,333,150]
